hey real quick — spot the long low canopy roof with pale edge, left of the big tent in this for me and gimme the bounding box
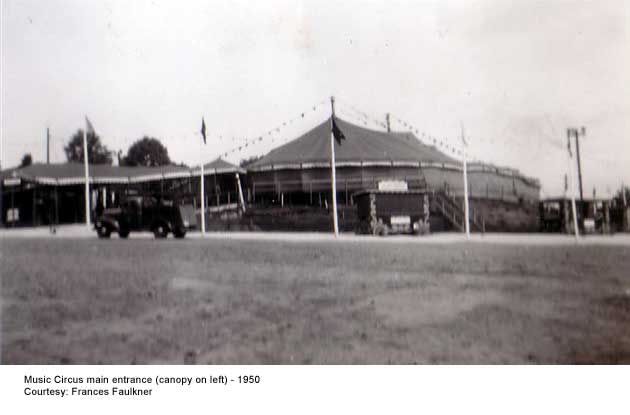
[0,158,244,185]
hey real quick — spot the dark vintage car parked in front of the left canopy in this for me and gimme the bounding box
[94,195,196,238]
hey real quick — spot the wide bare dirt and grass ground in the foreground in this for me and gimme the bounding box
[0,238,630,364]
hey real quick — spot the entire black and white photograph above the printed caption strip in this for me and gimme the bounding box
[0,0,630,410]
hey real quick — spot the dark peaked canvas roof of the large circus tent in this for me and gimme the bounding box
[248,118,461,171]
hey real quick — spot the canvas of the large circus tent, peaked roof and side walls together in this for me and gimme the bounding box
[247,118,540,202]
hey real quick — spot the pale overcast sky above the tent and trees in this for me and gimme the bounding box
[1,0,630,195]
